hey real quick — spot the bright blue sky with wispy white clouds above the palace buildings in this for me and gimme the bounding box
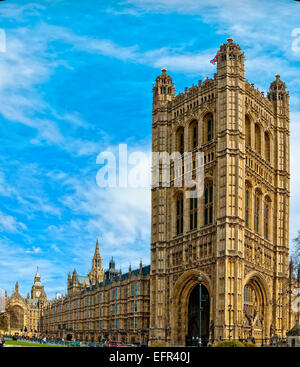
[0,0,300,297]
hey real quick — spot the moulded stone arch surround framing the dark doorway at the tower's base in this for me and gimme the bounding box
[170,270,213,346]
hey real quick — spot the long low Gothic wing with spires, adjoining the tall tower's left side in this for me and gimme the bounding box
[41,240,150,344]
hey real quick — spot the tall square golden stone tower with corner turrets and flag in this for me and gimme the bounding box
[150,39,293,345]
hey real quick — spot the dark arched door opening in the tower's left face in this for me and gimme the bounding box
[186,284,210,346]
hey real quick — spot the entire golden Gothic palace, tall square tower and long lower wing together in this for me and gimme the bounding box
[5,38,300,346]
